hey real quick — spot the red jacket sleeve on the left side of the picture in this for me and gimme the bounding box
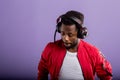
[37,43,51,80]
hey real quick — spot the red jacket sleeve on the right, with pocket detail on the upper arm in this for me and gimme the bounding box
[94,49,112,80]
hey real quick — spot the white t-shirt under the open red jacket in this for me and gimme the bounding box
[59,51,84,80]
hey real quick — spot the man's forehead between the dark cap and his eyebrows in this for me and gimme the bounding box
[61,24,76,32]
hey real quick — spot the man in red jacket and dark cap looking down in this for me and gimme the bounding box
[38,10,112,80]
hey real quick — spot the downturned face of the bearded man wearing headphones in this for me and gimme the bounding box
[60,24,78,49]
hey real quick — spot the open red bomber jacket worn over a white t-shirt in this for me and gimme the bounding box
[38,40,112,80]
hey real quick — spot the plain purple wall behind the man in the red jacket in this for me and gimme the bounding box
[0,0,120,79]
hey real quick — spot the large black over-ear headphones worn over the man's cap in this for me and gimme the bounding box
[54,15,88,42]
